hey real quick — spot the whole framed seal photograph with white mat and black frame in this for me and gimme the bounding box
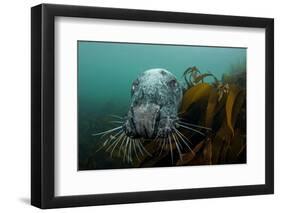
[31,4,274,208]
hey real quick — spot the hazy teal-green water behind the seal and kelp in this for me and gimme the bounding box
[77,41,247,170]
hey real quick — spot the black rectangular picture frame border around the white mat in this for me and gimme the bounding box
[31,4,274,209]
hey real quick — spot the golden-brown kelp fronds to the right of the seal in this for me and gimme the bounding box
[177,68,246,165]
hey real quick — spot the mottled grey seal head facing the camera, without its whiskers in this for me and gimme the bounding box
[124,68,182,139]
